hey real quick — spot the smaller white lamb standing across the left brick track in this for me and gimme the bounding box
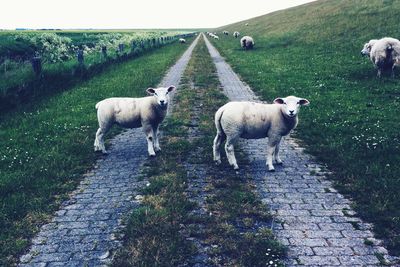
[94,85,175,156]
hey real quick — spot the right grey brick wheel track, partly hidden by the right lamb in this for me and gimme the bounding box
[206,34,394,266]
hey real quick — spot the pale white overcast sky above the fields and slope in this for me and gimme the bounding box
[0,0,318,29]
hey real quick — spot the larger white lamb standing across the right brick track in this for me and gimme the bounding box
[213,96,310,171]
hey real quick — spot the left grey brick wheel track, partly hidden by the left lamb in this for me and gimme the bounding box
[20,36,197,267]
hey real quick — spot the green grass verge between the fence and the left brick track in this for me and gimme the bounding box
[0,37,190,266]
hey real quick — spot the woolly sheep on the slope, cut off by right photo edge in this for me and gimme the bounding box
[369,37,400,78]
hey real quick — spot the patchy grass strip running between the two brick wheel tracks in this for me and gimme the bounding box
[113,36,285,266]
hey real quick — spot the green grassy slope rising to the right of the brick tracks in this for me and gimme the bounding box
[209,0,400,255]
